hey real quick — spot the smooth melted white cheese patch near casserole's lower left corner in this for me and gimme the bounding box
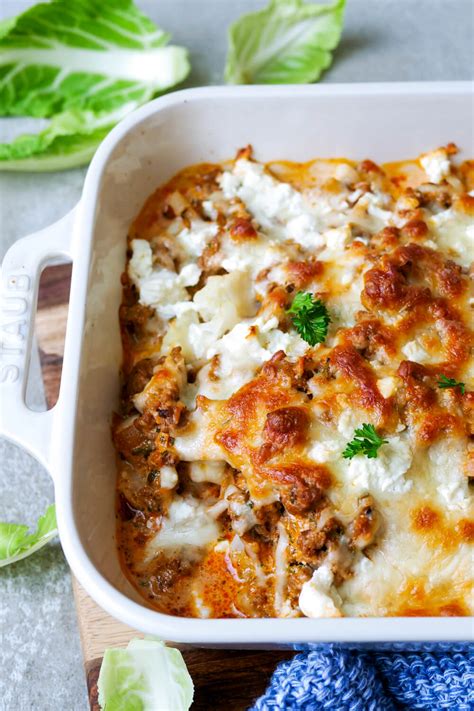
[147,496,220,559]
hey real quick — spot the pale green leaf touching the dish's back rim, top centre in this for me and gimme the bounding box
[225,0,345,84]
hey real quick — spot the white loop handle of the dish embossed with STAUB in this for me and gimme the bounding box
[0,208,76,476]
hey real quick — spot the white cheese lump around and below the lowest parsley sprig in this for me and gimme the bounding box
[348,436,413,494]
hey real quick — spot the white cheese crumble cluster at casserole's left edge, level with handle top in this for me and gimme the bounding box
[128,239,201,319]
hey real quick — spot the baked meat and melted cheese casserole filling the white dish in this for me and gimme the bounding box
[114,145,474,617]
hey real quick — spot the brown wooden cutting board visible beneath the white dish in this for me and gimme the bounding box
[35,264,293,711]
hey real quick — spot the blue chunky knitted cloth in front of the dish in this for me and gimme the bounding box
[251,646,474,711]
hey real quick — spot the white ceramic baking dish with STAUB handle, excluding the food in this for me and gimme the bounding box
[0,83,474,646]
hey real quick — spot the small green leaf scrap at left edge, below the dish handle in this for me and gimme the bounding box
[0,504,58,568]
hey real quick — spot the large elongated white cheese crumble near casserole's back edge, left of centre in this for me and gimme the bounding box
[220,159,323,249]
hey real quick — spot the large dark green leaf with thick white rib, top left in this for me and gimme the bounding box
[0,0,189,170]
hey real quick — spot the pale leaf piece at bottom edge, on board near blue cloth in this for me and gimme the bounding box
[98,639,194,711]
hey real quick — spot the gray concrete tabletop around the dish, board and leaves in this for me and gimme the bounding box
[0,0,473,711]
